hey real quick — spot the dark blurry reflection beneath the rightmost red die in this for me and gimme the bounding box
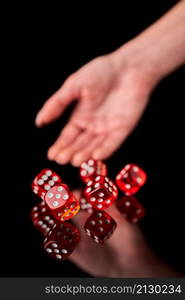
[116,196,145,223]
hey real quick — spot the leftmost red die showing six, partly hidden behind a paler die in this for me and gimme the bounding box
[31,169,62,200]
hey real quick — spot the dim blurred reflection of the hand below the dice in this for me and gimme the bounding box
[70,191,182,277]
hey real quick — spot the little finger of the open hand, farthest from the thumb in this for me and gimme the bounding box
[92,129,128,160]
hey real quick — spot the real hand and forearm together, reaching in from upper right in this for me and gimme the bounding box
[36,1,185,166]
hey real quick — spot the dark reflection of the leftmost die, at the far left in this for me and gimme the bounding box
[31,201,56,235]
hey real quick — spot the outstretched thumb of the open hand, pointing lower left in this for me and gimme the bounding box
[35,75,80,127]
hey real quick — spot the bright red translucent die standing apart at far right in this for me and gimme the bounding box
[116,164,146,195]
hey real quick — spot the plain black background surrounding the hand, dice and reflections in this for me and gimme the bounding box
[0,1,185,277]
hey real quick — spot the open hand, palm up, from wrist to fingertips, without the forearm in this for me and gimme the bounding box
[36,49,152,166]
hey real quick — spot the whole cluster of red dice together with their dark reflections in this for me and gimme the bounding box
[31,159,146,260]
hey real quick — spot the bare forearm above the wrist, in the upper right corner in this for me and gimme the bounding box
[114,0,185,82]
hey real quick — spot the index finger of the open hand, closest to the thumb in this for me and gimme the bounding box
[48,123,81,160]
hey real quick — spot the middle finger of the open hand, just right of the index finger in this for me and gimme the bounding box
[55,131,93,164]
